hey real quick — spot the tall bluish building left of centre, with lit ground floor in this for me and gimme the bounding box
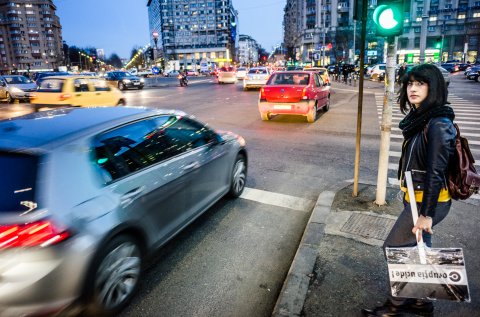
[147,0,238,69]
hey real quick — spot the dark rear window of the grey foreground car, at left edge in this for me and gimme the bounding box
[0,152,38,213]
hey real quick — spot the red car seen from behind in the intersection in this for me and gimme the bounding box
[258,71,330,123]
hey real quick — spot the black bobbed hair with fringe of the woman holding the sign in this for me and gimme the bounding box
[398,64,448,114]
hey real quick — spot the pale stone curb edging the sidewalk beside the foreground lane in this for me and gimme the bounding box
[272,181,350,317]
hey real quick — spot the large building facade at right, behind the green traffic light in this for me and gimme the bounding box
[284,0,480,65]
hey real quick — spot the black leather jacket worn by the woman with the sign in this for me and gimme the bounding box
[398,117,456,217]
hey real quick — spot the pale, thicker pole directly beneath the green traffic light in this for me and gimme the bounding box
[375,37,397,206]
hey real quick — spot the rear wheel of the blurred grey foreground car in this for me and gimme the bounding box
[85,235,143,316]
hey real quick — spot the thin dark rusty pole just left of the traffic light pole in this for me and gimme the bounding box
[352,0,367,197]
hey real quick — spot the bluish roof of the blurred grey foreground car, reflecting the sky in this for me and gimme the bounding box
[0,107,185,150]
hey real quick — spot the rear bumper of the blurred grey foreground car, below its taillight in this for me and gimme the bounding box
[0,239,93,316]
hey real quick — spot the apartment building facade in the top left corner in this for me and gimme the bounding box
[0,0,64,73]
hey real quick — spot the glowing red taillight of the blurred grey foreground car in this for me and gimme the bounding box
[0,220,70,250]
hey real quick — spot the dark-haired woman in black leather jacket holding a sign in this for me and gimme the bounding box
[362,64,456,316]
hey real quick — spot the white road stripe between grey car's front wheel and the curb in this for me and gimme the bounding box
[240,187,315,211]
